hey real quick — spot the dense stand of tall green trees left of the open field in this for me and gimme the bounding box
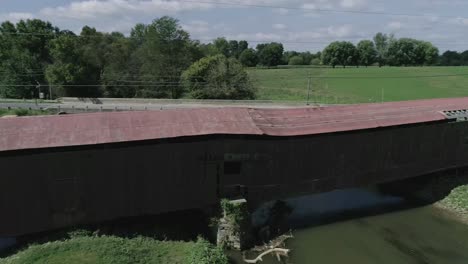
[0,17,255,99]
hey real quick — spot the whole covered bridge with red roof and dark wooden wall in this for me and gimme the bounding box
[0,98,468,236]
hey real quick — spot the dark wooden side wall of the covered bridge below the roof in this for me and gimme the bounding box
[0,122,468,236]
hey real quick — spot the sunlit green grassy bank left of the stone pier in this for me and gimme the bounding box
[0,234,227,264]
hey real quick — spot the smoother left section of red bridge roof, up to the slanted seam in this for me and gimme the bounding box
[0,108,262,151]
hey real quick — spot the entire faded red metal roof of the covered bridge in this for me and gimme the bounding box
[0,98,468,151]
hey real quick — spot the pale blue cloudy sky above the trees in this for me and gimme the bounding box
[0,0,468,52]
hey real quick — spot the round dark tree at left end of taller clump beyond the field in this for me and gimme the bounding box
[322,41,358,68]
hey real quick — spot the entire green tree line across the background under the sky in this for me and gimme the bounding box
[0,16,468,99]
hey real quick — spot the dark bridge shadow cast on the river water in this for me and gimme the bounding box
[253,174,468,232]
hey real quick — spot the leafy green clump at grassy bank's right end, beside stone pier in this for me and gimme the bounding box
[187,238,229,264]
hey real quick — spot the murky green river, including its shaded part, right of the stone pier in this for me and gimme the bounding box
[231,189,468,264]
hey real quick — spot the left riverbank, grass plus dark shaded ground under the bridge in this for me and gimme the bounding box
[0,210,227,264]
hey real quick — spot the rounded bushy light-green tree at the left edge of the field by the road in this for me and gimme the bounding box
[181,55,255,100]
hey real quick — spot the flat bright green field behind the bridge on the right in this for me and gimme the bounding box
[248,67,468,104]
